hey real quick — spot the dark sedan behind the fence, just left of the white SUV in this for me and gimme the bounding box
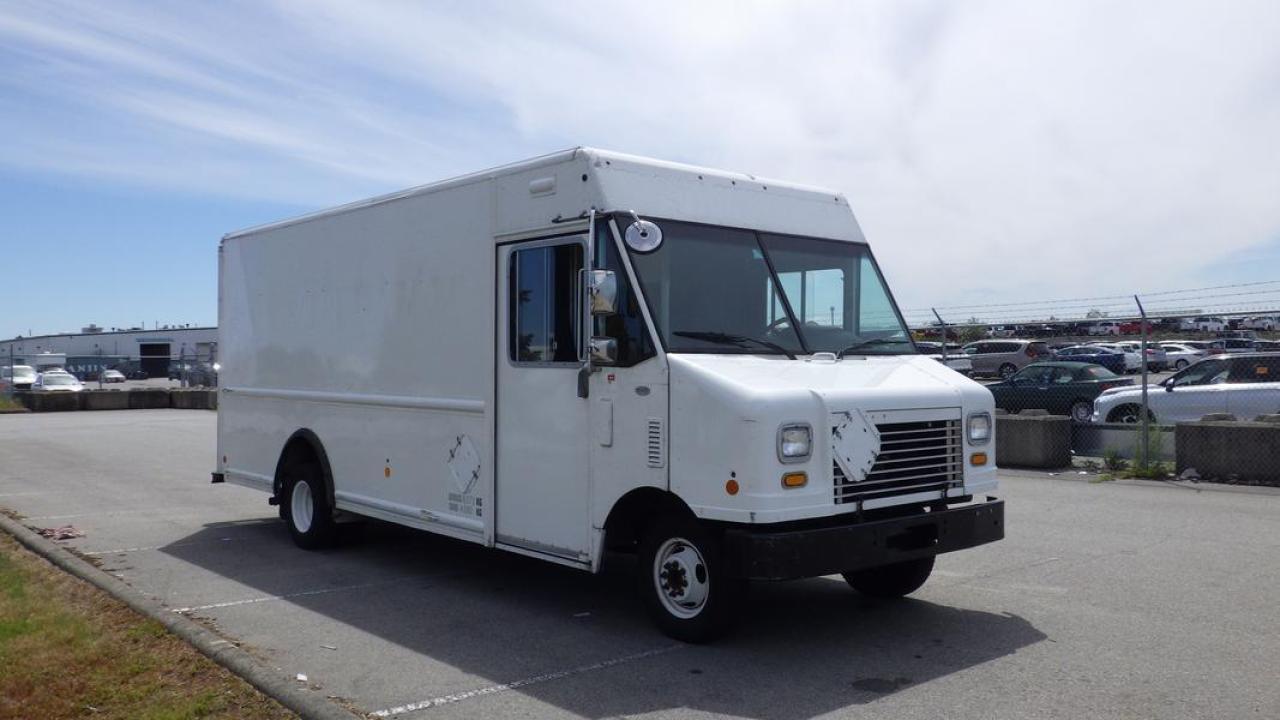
[987,361,1133,423]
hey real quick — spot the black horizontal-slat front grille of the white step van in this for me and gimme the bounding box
[832,420,964,505]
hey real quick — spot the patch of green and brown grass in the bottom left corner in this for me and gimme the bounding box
[0,533,294,720]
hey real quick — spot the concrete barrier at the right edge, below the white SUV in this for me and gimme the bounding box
[1174,418,1280,487]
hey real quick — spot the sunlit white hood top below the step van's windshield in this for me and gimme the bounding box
[668,354,992,411]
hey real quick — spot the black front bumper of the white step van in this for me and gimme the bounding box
[723,498,1005,580]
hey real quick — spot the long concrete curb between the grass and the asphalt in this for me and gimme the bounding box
[0,514,358,720]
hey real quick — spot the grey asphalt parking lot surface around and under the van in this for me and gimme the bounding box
[0,410,1280,720]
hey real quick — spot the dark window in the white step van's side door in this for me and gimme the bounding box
[507,242,584,365]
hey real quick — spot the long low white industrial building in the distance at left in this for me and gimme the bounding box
[0,325,218,378]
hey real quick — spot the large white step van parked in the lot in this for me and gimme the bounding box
[214,149,1004,642]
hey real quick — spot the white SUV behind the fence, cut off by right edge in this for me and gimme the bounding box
[1093,352,1280,423]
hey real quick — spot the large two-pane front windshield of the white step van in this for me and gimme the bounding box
[617,217,916,355]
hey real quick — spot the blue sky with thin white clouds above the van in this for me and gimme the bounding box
[0,0,1280,337]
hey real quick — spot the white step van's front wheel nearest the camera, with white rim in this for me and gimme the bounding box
[637,519,746,643]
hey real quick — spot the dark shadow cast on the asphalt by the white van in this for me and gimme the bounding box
[163,512,1046,720]
